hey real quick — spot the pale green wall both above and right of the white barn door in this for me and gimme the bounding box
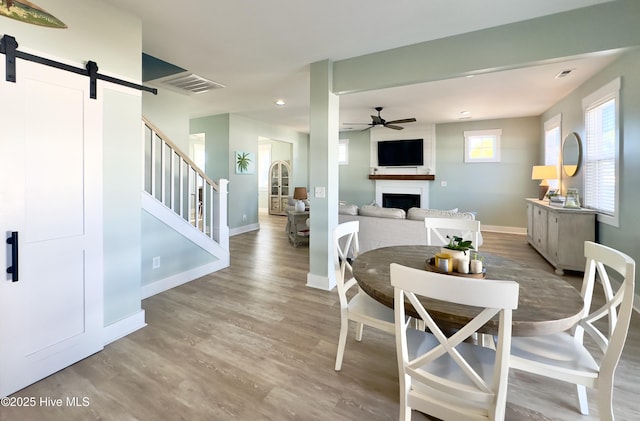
[0,0,142,326]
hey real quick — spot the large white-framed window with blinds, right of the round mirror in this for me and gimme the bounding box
[582,78,620,226]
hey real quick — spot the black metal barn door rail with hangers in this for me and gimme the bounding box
[0,34,158,99]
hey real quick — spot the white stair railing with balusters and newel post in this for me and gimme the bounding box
[142,117,229,250]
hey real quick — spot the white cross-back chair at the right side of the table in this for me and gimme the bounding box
[510,241,636,421]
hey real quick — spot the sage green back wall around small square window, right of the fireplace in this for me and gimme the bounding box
[436,117,540,228]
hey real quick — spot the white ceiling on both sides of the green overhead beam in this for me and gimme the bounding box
[102,0,615,132]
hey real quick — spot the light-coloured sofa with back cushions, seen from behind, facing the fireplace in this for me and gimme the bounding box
[338,204,482,253]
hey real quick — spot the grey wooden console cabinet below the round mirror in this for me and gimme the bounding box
[526,199,596,275]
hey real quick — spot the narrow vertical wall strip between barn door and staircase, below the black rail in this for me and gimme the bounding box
[103,90,142,326]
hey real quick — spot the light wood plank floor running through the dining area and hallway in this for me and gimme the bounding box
[0,215,640,421]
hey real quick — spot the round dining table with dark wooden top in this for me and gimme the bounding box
[352,246,584,336]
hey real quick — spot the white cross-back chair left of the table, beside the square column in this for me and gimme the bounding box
[333,221,395,371]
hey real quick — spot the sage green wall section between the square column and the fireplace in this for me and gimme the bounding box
[338,130,376,206]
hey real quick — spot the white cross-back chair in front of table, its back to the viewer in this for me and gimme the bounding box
[391,263,519,421]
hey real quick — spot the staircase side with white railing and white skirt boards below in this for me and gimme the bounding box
[141,118,229,298]
